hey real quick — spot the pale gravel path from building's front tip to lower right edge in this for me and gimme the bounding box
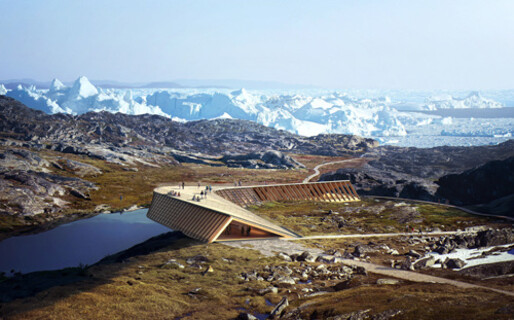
[223,239,514,297]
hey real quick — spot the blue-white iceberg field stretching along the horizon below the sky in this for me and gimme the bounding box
[0,77,514,146]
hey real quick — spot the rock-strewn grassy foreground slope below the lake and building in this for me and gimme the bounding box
[0,225,513,319]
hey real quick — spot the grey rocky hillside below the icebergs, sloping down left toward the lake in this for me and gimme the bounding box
[0,96,378,220]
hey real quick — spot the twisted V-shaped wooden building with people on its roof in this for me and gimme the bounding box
[147,181,360,242]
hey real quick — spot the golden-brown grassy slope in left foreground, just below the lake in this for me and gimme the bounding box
[0,234,283,319]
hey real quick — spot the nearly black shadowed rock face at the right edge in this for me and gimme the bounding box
[436,157,514,209]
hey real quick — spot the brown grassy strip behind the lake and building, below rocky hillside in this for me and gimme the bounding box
[0,150,328,240]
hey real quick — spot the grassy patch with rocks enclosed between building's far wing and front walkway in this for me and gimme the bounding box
[249,198,504,236]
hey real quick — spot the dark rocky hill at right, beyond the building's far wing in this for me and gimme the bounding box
[320,140,514,214]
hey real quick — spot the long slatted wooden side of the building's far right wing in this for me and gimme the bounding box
[216,180,360,207]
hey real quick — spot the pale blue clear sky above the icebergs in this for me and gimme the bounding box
[0,0,514,90]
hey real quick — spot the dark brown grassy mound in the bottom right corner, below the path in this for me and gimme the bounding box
[286,282,514,319]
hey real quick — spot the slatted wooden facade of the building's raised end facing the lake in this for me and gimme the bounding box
[147,192,232,242]
